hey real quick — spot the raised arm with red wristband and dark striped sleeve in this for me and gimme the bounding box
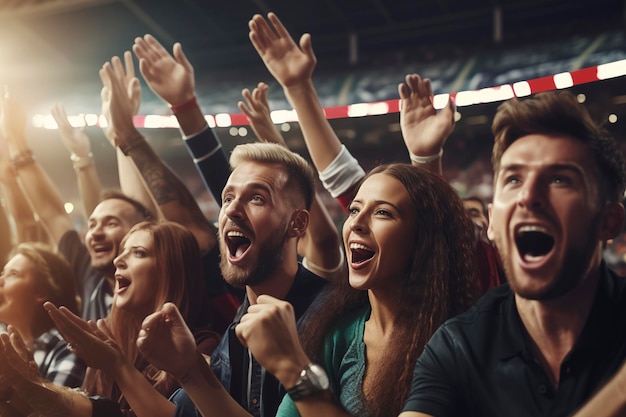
[133,35,230,204]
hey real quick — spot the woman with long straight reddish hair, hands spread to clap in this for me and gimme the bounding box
[0,221,219,417]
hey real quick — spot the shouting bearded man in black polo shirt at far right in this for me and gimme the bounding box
[401,92,626,417]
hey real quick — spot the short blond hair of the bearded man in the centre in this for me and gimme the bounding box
[230,143,315,210]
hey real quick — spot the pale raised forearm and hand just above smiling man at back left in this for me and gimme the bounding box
[51,104,102,217]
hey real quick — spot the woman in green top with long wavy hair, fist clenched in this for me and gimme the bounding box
[237,163,479,416]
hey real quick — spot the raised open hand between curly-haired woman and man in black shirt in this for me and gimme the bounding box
[398,74,455,156]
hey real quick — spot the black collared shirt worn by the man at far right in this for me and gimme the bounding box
[404,265,626,417]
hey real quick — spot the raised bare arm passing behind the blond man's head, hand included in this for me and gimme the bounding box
[237,83,345,280]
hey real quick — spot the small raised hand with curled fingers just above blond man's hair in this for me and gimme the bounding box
[237,82,287,147]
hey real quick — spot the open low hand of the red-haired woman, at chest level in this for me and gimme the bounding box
[44,302,125,372]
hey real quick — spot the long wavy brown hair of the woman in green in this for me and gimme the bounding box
[300,163,480,416]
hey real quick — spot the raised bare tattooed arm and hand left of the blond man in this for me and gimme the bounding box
[100,57,217,251]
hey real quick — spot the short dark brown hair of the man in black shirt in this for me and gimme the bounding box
[491,91,626,202]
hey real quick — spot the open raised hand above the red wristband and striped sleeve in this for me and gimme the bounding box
[133,35,195,106]
